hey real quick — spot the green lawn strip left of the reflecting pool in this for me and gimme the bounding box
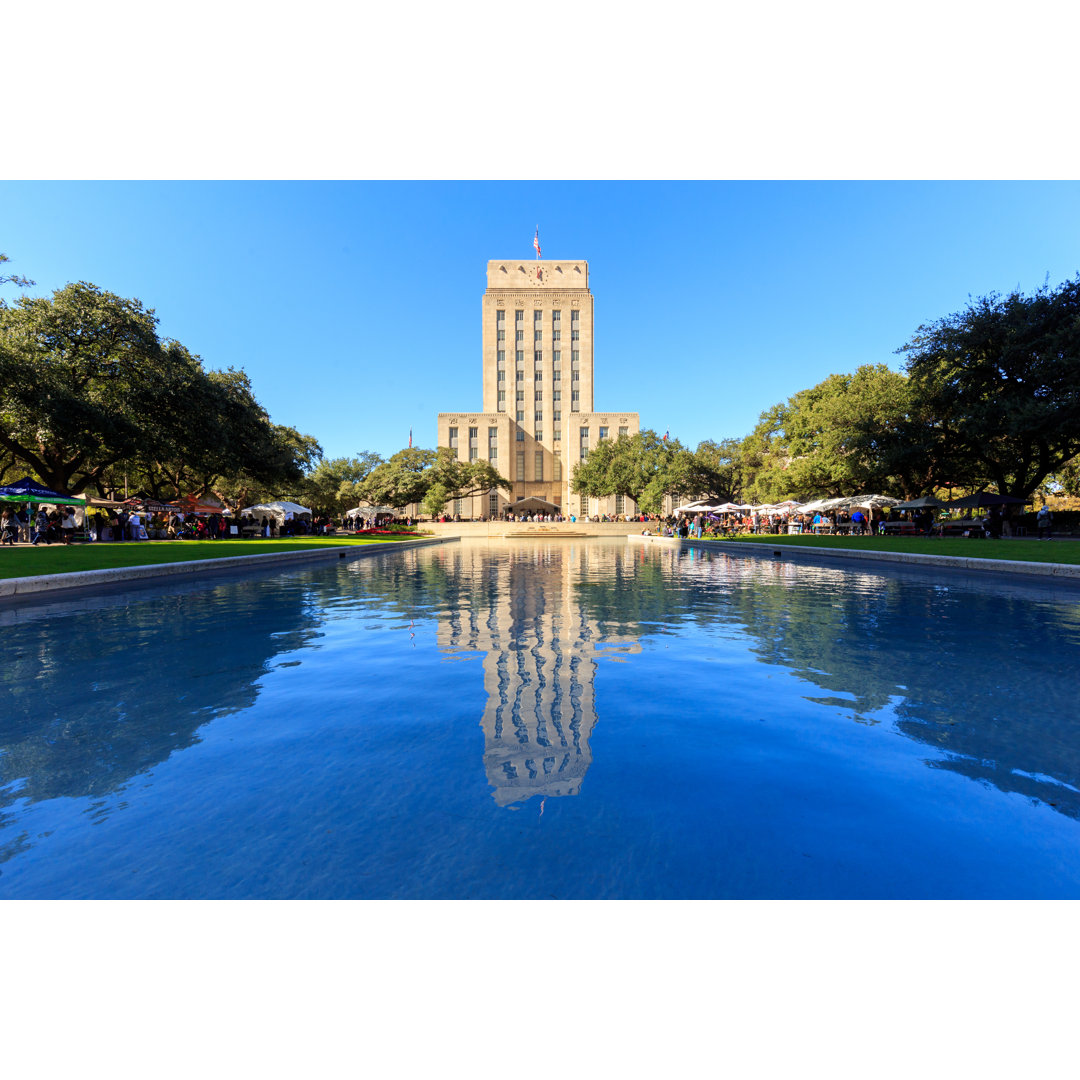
[0,536,425,578]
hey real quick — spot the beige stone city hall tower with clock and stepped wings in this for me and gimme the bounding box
[437,259,639,518]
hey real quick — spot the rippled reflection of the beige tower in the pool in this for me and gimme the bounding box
[438,541,640,806]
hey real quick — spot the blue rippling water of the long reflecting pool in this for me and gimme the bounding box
[0,540,1080,899]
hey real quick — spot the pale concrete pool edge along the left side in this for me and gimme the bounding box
[0,537,457,604]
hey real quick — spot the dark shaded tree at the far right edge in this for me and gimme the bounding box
[897,275,1080,498]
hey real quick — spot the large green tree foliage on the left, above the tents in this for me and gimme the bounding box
[0,282,322,498]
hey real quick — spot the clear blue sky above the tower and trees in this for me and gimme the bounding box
[0,181,1080,457]
